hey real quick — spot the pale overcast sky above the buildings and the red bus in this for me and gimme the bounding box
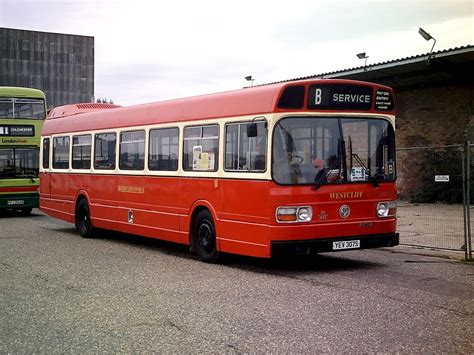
[0,0,474,105]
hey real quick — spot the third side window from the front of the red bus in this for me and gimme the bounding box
[148,128,179,171]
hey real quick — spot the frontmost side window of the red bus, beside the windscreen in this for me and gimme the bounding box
[225,122,267,172]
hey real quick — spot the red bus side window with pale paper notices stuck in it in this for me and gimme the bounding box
[183,125,219,171]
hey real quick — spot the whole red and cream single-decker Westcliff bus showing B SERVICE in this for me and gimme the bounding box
[40,80,399,262]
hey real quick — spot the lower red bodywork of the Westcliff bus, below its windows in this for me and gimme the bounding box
[40,174,396,257]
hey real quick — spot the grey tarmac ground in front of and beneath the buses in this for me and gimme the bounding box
[0,210,474,354]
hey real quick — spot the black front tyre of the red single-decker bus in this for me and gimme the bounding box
[193,210,219,263]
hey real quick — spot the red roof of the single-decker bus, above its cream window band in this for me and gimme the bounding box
[42,79,392,135]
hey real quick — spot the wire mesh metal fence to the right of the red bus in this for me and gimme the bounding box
[397,142,474,260]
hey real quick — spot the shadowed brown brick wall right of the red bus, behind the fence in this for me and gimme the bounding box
[396,84,474,202]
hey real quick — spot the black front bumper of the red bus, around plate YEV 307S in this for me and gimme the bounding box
[271,233,400,256]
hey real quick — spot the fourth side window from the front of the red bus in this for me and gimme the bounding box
[119,131,145,170]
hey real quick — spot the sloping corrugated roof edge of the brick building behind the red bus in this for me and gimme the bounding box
[262,45,474,85]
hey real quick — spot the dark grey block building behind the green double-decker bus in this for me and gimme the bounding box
[0,27,94,107]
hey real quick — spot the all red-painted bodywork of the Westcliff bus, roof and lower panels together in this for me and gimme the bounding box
[40,80,397,257]
